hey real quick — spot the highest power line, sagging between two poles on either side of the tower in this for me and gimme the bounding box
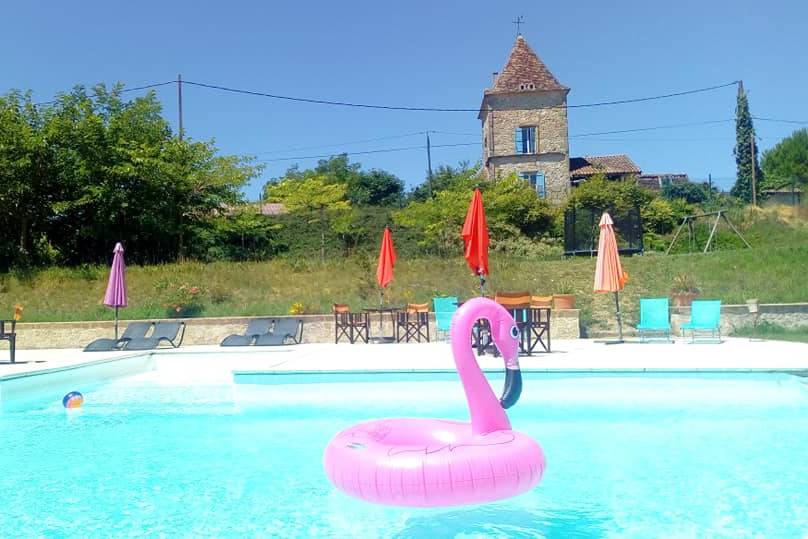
[183,81,738,112]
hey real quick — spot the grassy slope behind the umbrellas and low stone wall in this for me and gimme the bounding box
[0,209,808,329]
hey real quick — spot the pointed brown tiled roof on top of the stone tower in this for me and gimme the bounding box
[485,36,569,94]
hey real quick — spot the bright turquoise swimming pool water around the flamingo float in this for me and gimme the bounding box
[0,371,808,538]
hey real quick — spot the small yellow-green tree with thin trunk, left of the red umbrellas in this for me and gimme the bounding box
[264,176,351,260]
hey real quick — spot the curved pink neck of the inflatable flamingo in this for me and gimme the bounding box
[451,300,511,435]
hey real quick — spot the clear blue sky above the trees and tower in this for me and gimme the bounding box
[0,0,808,198]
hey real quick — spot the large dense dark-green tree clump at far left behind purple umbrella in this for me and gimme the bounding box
[0,85,259,265]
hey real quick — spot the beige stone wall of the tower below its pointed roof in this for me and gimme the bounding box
[481,90,570,202]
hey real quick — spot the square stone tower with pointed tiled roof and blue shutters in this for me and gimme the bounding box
[479,35,570,202]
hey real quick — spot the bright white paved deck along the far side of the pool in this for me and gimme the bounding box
[0,338,808,381]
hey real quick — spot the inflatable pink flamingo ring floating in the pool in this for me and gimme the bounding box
[324,298,545,507]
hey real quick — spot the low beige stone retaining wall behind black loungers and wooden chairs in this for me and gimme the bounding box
[0,309,580,349]
